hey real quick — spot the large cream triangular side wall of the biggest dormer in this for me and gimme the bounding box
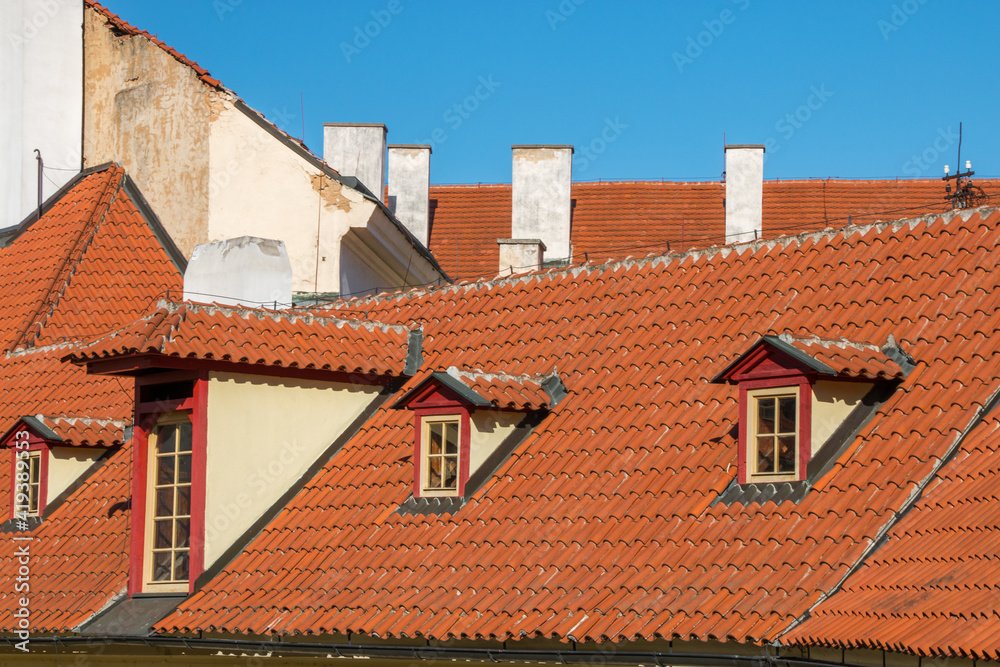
[205,373,380,567]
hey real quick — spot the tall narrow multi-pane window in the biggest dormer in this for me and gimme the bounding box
[146,414,191,591]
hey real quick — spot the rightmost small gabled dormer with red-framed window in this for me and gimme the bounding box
[712,334,913,485]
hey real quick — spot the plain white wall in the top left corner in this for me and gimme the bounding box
[0,0,83,228]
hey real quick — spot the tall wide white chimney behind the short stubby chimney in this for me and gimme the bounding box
[511,146,573,259]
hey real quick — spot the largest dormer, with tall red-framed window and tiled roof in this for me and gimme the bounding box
[66,301,422,597]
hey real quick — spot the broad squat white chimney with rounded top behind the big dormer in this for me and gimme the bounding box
[184,236,292,308]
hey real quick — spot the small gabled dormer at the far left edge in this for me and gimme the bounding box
[0,415,126,526]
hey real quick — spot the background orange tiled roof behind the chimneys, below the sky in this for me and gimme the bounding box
[428,179,1000,279]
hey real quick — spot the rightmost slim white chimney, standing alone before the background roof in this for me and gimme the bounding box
[726,144,764,243]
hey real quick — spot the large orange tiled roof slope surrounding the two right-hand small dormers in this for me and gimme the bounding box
[146,211,1000,657]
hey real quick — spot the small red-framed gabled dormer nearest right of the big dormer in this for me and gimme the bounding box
[393,367,566,513]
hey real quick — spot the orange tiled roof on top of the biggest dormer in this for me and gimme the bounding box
[66,301,409,375]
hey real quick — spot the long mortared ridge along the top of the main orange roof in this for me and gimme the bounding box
[325,206,1000,309]
